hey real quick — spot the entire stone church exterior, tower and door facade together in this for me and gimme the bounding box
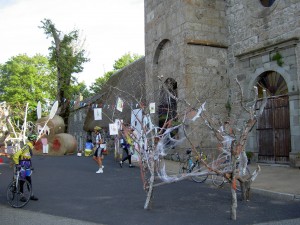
[145,0,300,163]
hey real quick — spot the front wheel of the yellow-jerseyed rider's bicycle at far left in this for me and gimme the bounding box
[6,180,32,208]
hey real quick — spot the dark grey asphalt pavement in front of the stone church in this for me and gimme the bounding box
[0,155,300,225]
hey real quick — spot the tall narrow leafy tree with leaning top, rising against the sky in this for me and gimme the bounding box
[40,19,89,126]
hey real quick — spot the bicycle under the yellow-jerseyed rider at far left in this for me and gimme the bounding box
[6,167,32,208]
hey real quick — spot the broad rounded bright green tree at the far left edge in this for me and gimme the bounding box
[0,54,56,122]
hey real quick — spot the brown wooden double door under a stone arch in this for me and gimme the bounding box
[257,71,291,163]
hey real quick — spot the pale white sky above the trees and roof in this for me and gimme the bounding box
[0,0,145,86]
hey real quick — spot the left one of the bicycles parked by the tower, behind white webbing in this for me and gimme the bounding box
[176,149,208,183]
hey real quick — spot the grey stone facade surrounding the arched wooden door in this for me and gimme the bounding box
[226,0,300,161]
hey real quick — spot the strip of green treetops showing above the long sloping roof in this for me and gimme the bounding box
[90,53,143,93]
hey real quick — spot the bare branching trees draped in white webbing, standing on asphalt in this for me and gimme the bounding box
[97,71,266,220]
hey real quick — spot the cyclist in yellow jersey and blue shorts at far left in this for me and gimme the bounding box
[12,134,38,201]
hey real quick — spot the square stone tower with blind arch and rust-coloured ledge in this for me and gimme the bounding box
[145,0,229,151]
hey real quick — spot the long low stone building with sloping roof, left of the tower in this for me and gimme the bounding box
[68,58,145,150]
